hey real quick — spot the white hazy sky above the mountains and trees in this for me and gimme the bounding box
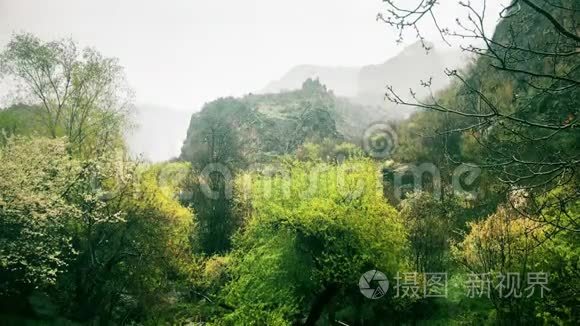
[0,0,508,111]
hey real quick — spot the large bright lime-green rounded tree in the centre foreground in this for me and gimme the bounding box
[218,160,405,324]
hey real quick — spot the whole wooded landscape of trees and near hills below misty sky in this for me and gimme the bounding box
[0,0,580,325]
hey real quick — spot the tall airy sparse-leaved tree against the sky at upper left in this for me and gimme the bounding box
[0,34,131,157]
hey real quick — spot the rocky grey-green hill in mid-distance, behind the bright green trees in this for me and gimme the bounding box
[181,79,374,163]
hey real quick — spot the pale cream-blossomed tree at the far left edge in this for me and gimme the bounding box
[0,137,81,295]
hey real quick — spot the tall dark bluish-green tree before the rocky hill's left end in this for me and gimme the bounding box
[181,98,248,255]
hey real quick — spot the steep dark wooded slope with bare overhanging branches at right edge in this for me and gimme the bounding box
[377,0,580,232]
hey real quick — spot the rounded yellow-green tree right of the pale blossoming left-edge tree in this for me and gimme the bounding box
[60,156,195,322]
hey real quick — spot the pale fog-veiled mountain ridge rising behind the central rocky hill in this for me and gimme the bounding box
[261,43,468,119]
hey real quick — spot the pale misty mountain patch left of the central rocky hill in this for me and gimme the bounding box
[126,105,191,162]
